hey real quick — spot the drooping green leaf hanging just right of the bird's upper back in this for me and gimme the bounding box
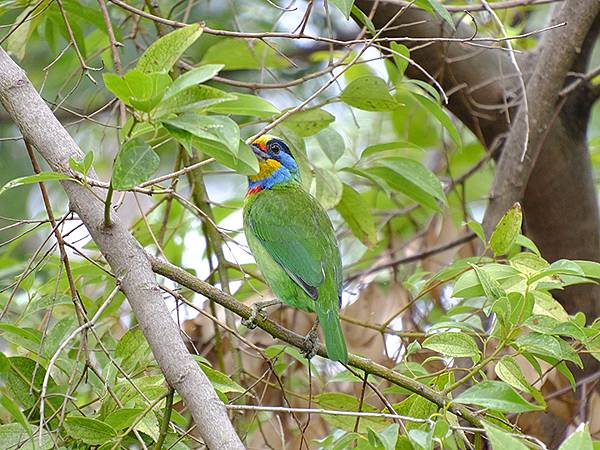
[336,183,376,247]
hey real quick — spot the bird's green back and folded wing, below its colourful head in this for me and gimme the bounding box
[246,188,335,299]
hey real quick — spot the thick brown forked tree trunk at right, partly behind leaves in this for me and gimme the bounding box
[356,0,600,442]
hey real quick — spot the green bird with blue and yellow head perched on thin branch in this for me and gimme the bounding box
[244,135,348,363]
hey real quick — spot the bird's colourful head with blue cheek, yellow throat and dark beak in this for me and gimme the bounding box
[248,134,300,194]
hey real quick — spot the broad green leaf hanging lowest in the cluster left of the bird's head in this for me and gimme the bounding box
[111,138,160,190]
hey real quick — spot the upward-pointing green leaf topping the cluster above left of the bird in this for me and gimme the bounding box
[136,23,202,73]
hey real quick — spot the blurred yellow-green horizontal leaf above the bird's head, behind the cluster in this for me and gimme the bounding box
[202,38,290,70]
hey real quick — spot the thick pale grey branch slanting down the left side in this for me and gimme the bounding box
[0,48,244,449]
